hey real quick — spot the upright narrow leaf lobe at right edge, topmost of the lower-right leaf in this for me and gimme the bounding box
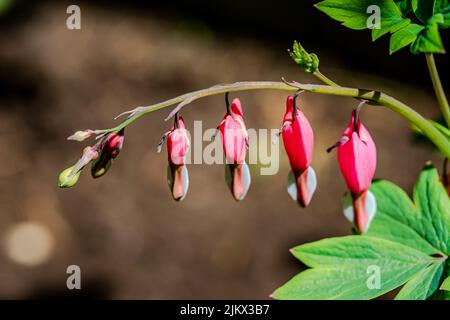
[413,164,450,255]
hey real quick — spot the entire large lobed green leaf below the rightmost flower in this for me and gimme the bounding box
[273,164,450,299]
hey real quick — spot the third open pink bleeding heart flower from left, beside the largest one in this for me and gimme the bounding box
[282,96,317,207]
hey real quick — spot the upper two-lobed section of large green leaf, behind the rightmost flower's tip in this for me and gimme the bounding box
[367,164,450,255]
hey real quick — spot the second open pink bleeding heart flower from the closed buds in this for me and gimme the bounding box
[218,94,251,201]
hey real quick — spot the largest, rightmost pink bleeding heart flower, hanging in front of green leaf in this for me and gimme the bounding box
[335,108,377,233]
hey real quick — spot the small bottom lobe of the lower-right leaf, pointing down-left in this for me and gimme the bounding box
[395,259,445,300]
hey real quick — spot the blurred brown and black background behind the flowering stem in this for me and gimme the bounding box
[0,0,444,299]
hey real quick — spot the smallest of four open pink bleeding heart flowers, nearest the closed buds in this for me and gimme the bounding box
[166,114,190,201]
